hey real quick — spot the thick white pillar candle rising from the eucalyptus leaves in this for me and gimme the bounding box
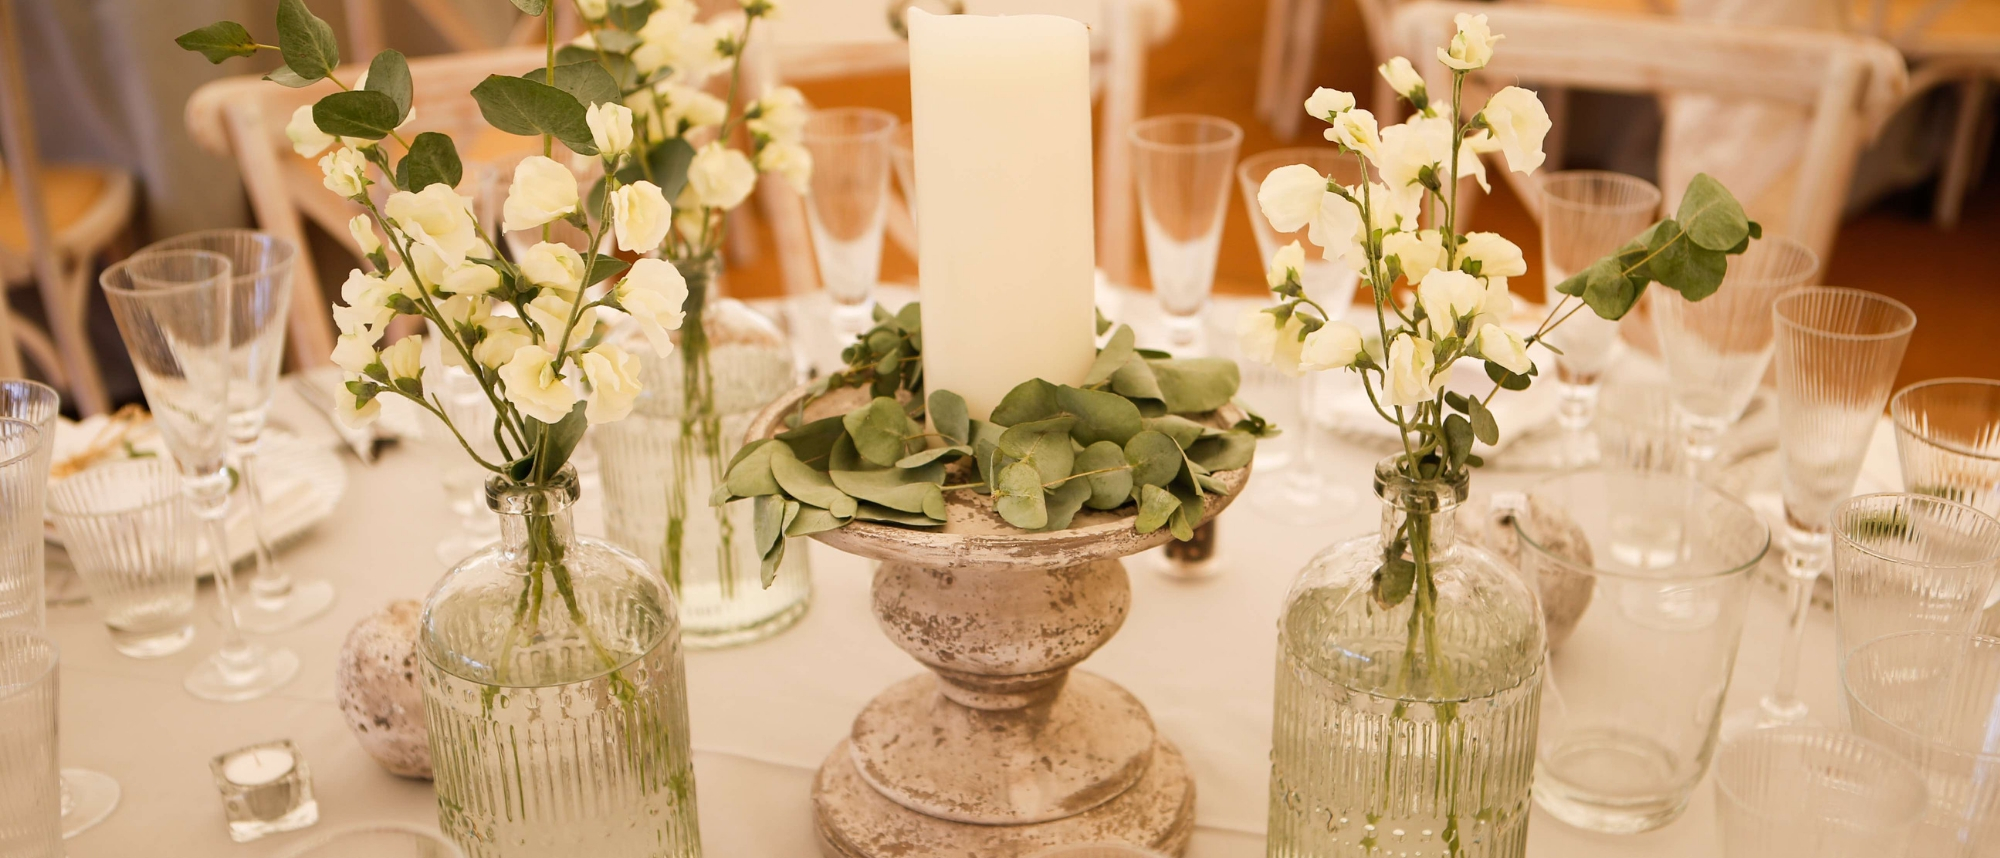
[908,8,1096,418]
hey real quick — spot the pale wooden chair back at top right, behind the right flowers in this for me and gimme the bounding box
[1394,0,1908,266]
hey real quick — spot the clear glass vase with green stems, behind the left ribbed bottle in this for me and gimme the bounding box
[590,258,812,650]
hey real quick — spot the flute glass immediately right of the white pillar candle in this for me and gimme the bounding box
[1126,114,1244,348]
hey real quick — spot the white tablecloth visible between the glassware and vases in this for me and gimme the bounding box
[50,350,1898,858]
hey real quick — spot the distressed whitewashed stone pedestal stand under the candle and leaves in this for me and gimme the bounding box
[750,390,1250,858]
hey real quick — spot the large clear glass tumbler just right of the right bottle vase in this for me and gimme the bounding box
[1514,470,1770,832]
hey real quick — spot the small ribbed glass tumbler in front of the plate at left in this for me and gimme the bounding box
[48,458,196,658]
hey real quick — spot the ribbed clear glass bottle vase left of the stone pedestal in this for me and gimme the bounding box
[418,468,702,858]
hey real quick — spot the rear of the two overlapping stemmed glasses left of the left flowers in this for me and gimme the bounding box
[138,230,334,634]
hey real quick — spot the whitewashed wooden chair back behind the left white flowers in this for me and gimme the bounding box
[186,48,544,366]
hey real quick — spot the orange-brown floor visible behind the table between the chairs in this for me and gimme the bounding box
[752,0,2000,382]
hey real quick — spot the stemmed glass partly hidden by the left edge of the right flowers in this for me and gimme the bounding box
[1236,146,1376,524]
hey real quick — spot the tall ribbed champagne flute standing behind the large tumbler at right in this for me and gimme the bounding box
[1752,288,1916,734]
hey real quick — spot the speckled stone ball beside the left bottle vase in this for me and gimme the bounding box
[334,598,430,780]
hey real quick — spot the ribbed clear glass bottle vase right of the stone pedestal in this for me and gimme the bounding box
[1268,456,1546,858]
